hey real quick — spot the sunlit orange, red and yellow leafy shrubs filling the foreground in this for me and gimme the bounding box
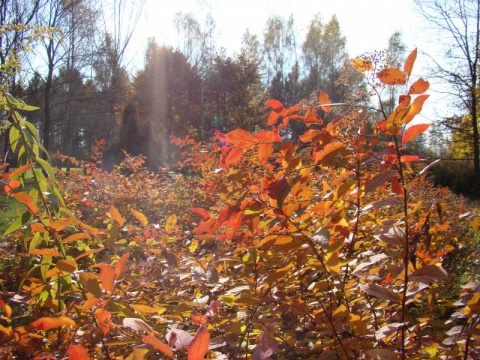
[0,51,480,360]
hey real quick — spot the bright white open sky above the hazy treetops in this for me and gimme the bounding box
[126,0,442,120]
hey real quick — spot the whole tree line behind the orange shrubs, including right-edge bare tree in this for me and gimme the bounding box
[0,0,480,195]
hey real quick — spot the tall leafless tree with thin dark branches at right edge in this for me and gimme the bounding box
[416,0,480,195]
